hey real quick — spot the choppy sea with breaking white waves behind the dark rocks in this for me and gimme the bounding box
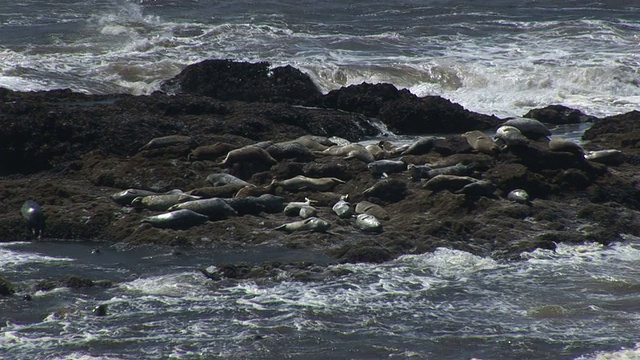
[0,0,640,116]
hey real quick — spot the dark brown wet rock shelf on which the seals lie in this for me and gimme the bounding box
[0,61,640,279]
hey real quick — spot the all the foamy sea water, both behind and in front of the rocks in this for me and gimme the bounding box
[0,0,640,360]
